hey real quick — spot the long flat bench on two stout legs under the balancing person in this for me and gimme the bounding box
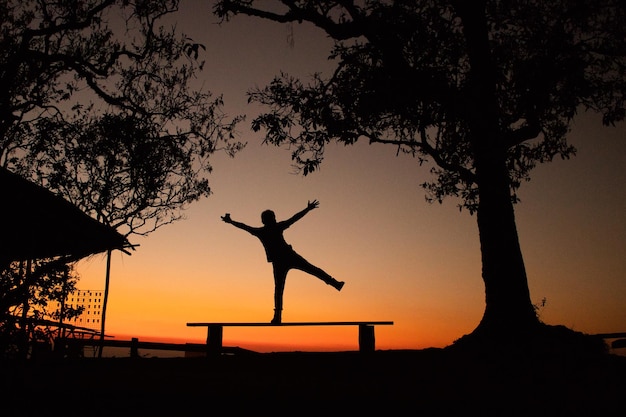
[187,321,393,355]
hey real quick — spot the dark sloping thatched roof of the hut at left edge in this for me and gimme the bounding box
[0,168,128,264]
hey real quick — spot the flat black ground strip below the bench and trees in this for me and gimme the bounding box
[0,349,626,417]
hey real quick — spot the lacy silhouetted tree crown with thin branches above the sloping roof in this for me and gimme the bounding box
[0,0,243,235]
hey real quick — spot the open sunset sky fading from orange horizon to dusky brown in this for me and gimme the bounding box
[78,1,626,351]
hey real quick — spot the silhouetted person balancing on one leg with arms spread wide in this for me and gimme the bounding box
[222,200,344,324]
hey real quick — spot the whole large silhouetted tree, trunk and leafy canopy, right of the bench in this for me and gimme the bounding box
[214,0,626,340]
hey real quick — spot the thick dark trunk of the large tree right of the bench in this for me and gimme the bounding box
[455,1,539,340]
